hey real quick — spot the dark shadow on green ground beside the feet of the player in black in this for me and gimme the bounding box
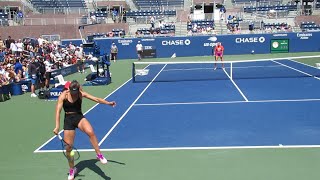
[76,159,125,180]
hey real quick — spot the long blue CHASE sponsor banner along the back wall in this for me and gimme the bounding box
[61,32,320,59]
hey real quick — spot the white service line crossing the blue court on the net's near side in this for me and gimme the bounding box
[135,99,320,106]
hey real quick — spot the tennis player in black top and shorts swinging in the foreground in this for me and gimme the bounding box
[53,80,116,179]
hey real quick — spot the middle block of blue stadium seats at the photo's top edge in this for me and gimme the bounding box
[134,0,184,9]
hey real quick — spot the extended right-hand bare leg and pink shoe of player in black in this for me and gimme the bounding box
[78,118,107,164]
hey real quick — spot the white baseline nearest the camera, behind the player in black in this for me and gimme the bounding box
[34,144,320,153]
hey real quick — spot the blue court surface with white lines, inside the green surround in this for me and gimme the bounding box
[35,60,320,152]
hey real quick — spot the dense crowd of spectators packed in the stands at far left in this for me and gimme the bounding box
[0,36,90,97]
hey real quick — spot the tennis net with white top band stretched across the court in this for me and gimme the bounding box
[132,56,320,82]
